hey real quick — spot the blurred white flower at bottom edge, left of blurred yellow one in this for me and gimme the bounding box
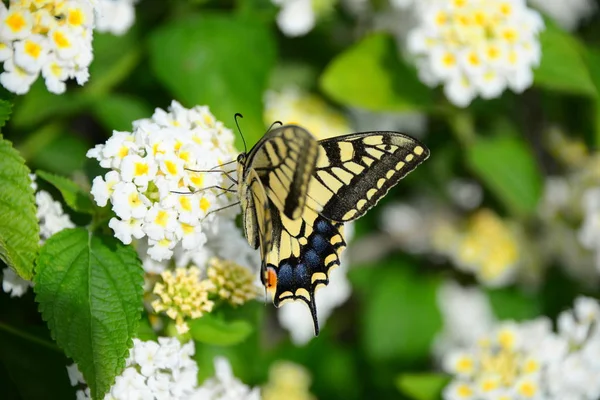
[197,357,261,400]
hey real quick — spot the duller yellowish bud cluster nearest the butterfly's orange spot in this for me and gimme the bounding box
[207,258,259,306]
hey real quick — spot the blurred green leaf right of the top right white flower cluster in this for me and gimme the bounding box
[534,23,598,97]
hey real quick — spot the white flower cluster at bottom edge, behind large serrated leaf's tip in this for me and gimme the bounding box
[67,337,201,400]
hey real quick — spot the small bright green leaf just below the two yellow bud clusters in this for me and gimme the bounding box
[188,314,254,346]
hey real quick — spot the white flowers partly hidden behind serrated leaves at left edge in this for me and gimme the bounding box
[2,174,75,297]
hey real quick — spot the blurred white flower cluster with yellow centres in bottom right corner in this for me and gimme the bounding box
[443,297,600,400]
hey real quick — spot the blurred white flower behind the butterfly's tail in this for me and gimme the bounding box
[277,223,354,346]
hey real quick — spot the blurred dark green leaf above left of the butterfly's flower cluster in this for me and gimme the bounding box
[93,94,152,132]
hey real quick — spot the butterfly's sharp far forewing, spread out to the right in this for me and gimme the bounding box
[308,132,429,222]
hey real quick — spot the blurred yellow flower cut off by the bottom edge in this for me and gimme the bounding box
[262,361,315,400]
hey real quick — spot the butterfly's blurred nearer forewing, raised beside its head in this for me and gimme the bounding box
[247,125,319,219]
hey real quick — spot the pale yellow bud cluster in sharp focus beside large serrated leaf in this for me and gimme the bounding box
[152,267,215,334]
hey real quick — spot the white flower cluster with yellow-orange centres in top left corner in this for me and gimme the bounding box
[0,0,94,94]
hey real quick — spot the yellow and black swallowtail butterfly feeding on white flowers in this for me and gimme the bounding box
[237,125,429,335]
